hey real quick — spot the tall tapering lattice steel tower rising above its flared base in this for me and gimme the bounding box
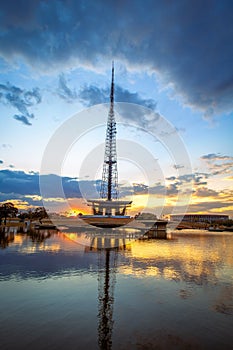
[100,62,118,201]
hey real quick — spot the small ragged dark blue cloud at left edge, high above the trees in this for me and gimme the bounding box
[0,83,41,125]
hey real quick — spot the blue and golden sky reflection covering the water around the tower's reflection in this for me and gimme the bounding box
[0,232,233,349]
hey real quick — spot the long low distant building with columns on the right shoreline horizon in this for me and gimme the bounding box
[170,214,229,223]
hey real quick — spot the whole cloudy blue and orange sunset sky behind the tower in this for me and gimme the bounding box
[0,0,233,217]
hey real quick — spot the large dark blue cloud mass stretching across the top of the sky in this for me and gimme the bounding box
[0,0,233,118]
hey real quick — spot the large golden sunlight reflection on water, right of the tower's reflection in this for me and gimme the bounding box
[116,232,233,285]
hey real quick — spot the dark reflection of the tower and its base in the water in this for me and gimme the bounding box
[85,236,129,350]
